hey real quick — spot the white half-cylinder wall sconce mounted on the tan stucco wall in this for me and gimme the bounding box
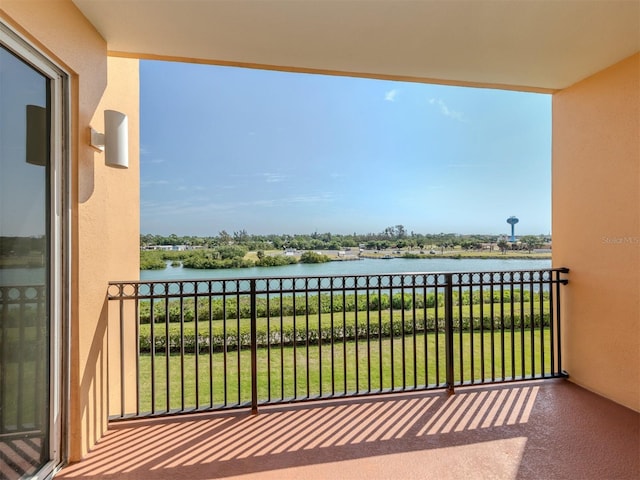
[90,110,129,168]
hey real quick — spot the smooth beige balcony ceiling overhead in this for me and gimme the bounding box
[73,0,640,91]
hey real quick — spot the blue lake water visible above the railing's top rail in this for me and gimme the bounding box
[139,258,551,281]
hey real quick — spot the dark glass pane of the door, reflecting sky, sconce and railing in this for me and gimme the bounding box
[0,46,51,479]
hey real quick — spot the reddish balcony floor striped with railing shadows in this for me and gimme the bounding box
[56,380,640,480]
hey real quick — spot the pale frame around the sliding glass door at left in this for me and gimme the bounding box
[0,20,71,479]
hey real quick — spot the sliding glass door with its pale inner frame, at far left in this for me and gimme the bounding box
[0,24,64,479]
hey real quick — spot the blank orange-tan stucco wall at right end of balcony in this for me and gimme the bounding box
[552,54,640,411]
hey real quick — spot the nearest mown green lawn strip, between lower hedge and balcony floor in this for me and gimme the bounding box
[139,328,551,412]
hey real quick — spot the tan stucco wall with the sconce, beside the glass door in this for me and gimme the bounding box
[0,0,139,461]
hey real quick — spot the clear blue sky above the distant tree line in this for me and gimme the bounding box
[140,61,551,236]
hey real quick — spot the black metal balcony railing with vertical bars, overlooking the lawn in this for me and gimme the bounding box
[108,268,568,419]
